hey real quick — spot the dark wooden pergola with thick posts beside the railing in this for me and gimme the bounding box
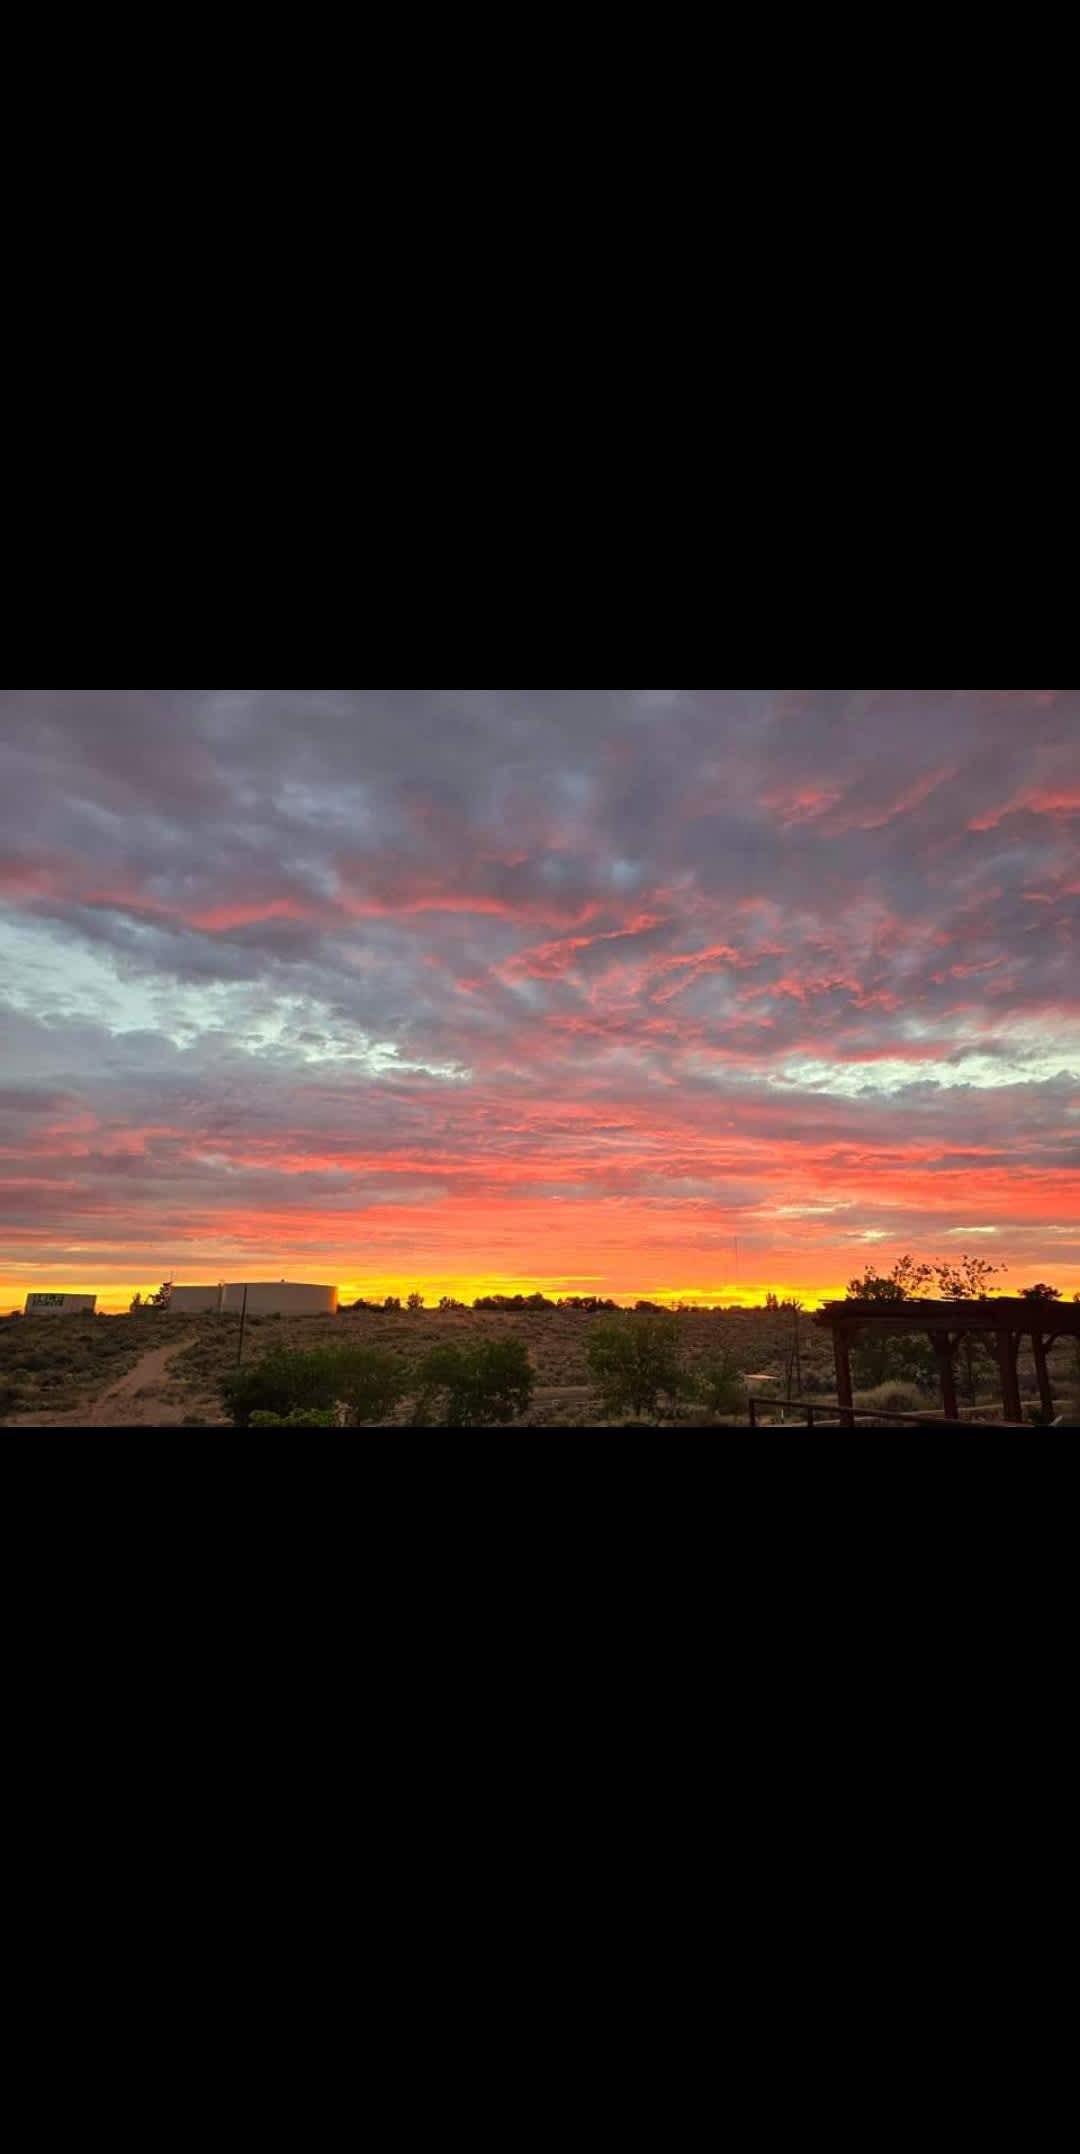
[811,1295,1080,1428]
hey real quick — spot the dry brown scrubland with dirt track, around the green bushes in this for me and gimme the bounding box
[0,1310,1080,1428]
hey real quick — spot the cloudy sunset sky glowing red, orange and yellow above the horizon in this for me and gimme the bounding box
[0,689,1080,1310]
